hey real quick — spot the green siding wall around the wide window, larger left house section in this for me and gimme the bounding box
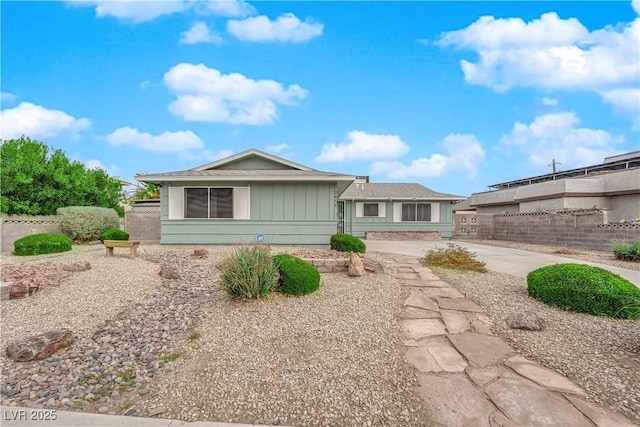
[161,182,336,247]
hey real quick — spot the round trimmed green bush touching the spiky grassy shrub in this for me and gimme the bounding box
[273,254,320,295]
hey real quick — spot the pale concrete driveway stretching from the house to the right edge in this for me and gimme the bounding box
[365,240,640,287]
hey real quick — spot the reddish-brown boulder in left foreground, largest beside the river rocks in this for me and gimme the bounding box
[7,329,73,362]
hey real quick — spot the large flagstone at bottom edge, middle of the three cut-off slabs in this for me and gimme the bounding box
[485,378,591,427]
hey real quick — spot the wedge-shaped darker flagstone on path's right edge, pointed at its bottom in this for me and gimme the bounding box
[448,332,513,367]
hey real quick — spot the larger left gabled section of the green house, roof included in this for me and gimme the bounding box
[136,149,356,247]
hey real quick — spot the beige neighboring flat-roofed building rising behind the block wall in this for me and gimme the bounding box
[453,151,640,222]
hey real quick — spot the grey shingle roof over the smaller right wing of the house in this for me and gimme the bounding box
[339,182,466,200]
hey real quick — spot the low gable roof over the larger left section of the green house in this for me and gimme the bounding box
[135,149,356,185]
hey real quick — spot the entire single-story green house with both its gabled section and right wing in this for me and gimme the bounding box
[136,149,464,247]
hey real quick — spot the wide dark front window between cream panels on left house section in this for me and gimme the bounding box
[184,188,233,218]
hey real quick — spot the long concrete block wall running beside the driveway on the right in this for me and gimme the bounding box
[453,210,640,251]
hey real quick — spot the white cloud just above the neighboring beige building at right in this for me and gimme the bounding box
[500,112,621,168]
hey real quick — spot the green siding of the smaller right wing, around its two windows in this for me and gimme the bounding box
[344,200,453,239]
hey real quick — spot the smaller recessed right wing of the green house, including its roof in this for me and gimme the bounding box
[338,179,465,238]
